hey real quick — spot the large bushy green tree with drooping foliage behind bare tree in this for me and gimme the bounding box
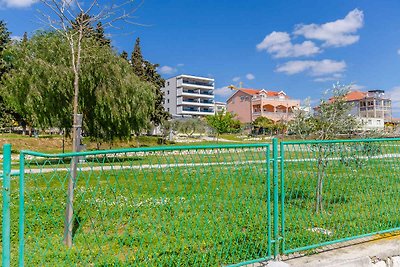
[1,32,155,140]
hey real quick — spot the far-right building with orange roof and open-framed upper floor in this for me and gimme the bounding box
[345,90,392,130]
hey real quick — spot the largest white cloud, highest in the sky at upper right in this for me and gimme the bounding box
[294,8,364,47]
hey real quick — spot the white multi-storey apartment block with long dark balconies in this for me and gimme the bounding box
[161,75,214,118]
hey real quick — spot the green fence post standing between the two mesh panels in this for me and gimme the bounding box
[272,138,279,258]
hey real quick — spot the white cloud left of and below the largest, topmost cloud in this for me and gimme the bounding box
[256,31,321,58]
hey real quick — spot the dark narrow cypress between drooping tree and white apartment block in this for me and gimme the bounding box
[131,37,169,125]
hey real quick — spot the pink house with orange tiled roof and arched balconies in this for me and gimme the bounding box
[226,88,300,123]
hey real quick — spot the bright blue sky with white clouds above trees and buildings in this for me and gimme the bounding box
[0,0,400,117]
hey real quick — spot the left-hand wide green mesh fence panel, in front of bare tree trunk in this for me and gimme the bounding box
[4,144,271,266]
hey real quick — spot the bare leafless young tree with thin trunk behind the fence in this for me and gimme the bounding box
[40,0,143,247]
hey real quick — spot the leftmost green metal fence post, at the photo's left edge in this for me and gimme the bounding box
[2,144,11,267]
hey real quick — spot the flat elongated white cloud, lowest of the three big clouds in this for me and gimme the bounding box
[276,59,346,76]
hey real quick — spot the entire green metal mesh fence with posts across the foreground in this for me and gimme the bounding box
[1,139,400,266]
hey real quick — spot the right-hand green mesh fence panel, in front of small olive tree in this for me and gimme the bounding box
[280,139,400,254]
